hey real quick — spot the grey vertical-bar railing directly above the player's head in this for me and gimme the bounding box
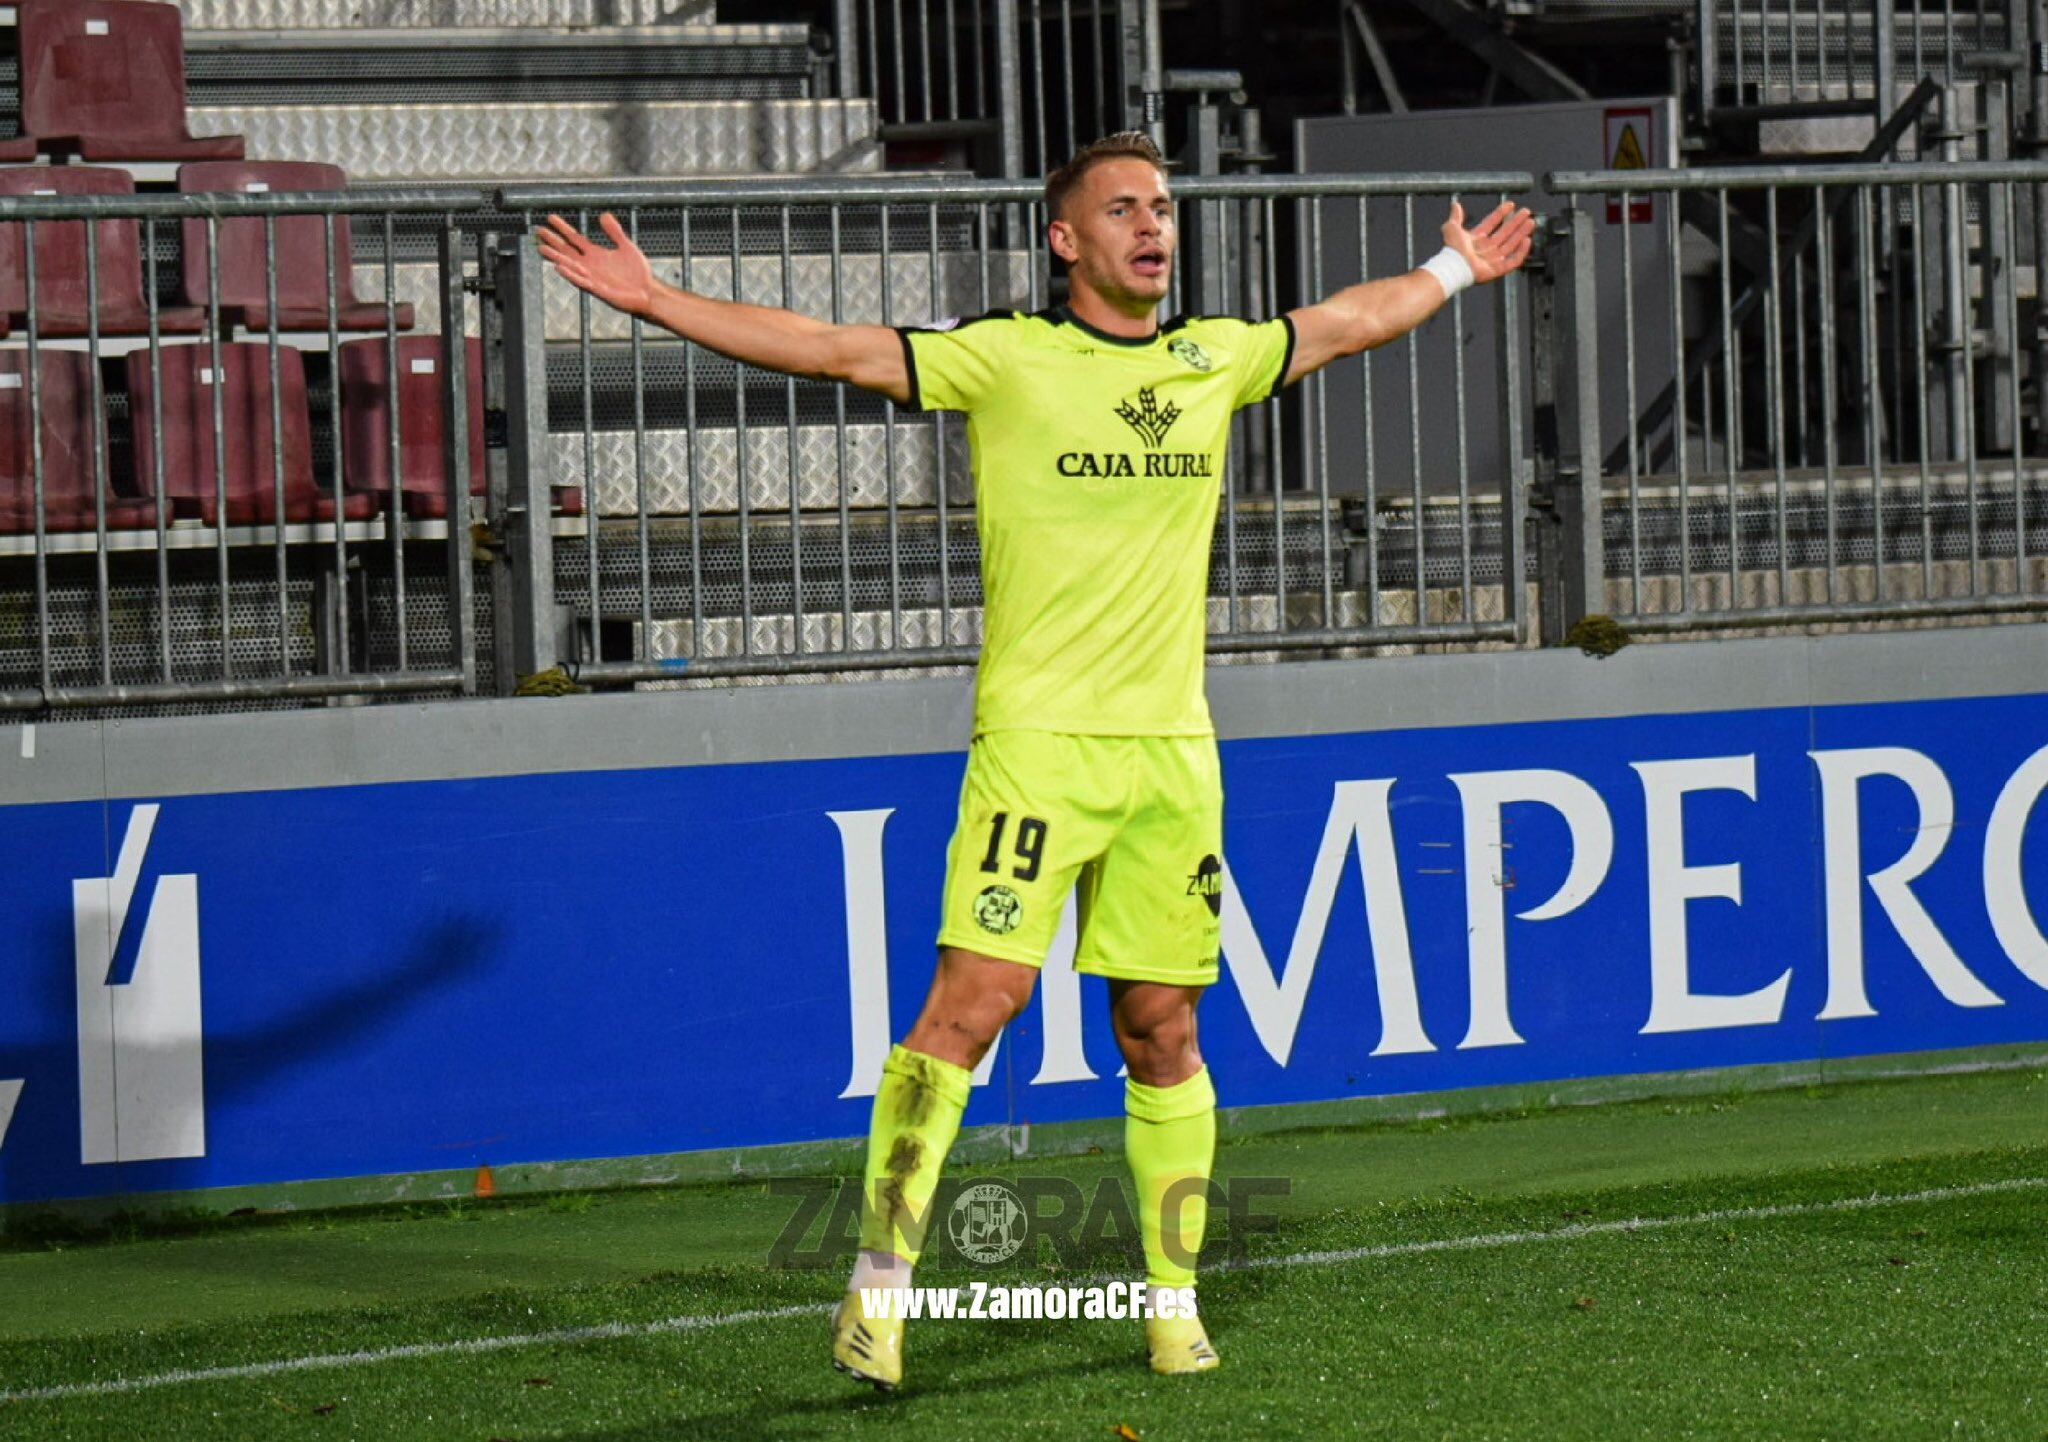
[834,0,1163,180]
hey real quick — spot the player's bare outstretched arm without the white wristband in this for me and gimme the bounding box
[535,213,909,404]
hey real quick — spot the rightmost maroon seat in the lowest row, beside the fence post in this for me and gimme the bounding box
[340,336,483,516]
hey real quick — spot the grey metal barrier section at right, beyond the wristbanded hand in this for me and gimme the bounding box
[1538,164,2048,631]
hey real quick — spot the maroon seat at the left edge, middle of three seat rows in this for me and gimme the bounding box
[0,166,207,336]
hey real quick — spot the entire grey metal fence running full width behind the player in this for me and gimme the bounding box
[12,164,2048,711]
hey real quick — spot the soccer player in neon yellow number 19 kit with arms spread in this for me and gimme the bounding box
[539,133,1534,1387]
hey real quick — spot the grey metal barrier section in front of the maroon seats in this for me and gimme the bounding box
[0,186,483,711]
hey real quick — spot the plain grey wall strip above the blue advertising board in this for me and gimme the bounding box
[0,625,2048,805]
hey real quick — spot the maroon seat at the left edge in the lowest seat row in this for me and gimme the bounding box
[0,350,156,533]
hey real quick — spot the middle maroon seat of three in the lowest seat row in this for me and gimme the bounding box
[125,342,377,526]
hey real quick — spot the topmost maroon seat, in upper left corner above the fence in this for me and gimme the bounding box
[0,0,242,160]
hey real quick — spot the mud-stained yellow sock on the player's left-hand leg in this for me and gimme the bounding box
[860,1047,973,1262]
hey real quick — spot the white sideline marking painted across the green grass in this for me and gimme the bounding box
[0,1176,2048,1407]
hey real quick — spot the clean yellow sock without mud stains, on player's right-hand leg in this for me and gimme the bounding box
[1124,1067,1217,1286]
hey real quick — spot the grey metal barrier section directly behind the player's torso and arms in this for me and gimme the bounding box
[496,174,1532,684]
